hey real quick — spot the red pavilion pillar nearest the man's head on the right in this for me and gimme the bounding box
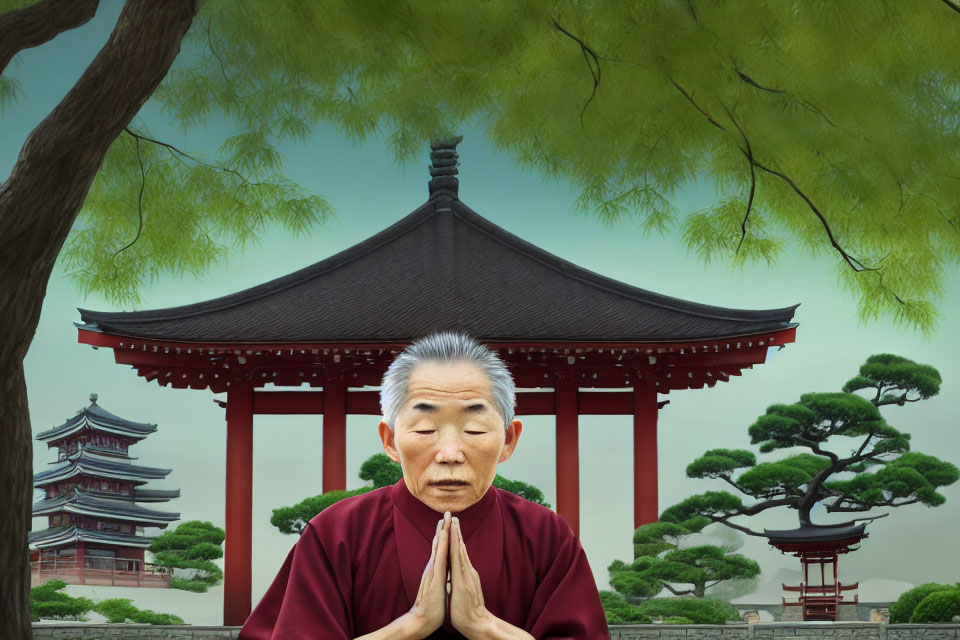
[556,380,580,536]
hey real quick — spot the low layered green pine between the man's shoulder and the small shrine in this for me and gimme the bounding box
[607,518,760,598]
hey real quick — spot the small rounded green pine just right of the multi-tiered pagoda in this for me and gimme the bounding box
[150,520,226,592]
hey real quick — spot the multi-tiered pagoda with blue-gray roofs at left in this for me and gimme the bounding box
[29,394,180,586]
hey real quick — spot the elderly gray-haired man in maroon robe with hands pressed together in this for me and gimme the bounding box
[240,333,609,640]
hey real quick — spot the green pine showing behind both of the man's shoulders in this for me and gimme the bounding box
[270,453,550,535]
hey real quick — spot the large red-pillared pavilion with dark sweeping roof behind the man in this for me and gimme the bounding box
[77,139,796,625]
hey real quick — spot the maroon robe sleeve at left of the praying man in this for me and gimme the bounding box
[238,524,353,640]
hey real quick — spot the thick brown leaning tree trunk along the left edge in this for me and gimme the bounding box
[0,0,197,640]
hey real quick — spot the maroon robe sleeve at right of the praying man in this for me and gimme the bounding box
[524,522,610,640]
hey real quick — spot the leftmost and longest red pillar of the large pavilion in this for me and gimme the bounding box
[223,382,253,626]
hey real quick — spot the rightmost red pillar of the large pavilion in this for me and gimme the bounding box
[633,381,660,528]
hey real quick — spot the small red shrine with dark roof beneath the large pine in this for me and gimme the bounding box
[764,522,869,620]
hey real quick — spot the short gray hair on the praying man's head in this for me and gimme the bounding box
[380,331,517,429]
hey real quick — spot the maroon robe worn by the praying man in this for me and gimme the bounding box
[240,479,610,640]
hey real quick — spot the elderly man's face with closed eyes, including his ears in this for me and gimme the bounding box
[380,362,523,513]
